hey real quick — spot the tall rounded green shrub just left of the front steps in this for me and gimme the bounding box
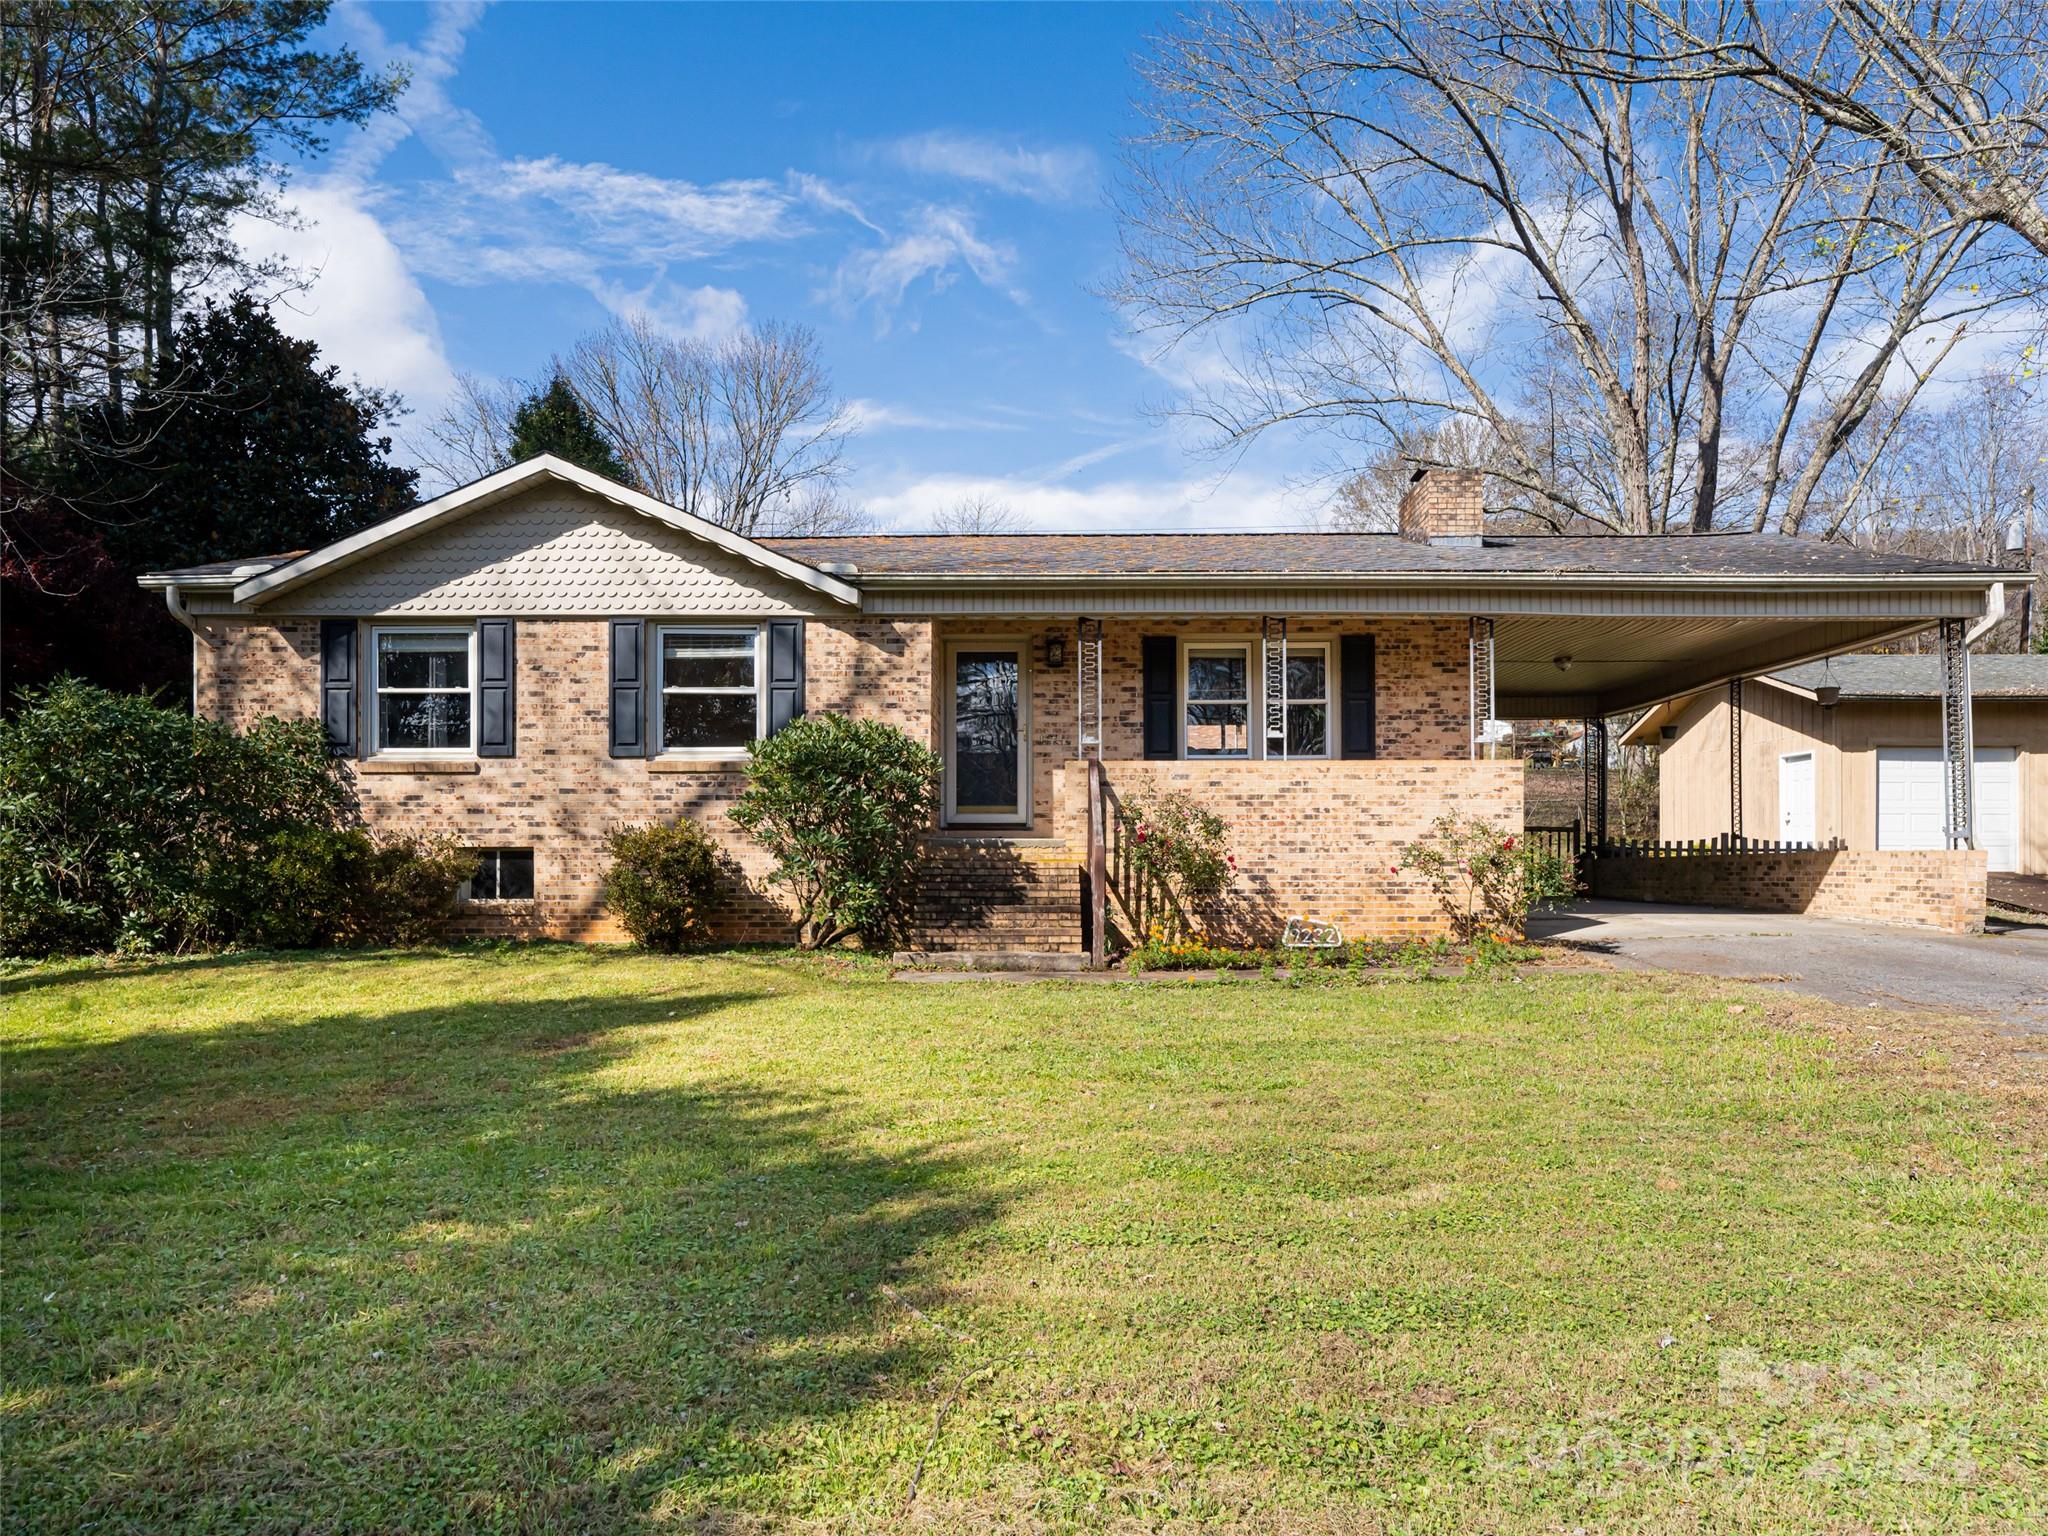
[731,715,940,948]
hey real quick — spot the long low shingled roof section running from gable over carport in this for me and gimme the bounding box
[762,532,2009,582]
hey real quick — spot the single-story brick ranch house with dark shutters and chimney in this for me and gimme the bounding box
[141,457,2007,952]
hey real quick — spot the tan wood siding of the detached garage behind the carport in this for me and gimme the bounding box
[1659,680,2048,874]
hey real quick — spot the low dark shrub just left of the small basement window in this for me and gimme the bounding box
[256,825,477,948]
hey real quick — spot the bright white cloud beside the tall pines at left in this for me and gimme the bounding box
[236,180,455,414]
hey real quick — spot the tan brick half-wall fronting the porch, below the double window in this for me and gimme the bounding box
[1059,760,1522,944]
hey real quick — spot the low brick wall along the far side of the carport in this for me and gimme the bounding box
[1591,848,1985,934]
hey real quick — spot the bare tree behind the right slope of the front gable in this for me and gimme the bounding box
[557,317,858,537]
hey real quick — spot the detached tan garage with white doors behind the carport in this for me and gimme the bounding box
[1622,655,2048,874]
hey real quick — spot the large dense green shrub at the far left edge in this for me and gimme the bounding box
[0,678,348,954]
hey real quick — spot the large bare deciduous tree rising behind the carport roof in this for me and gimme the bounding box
[1116,0,2032,532]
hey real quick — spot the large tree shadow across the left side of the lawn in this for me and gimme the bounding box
[0,967,999,1530]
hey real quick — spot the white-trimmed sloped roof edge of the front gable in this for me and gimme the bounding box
[199,453,860,608]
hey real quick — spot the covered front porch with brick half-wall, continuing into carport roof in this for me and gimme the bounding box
[913,580,1982,958]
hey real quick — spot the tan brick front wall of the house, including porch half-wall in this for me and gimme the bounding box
[195,616,1482,944]
